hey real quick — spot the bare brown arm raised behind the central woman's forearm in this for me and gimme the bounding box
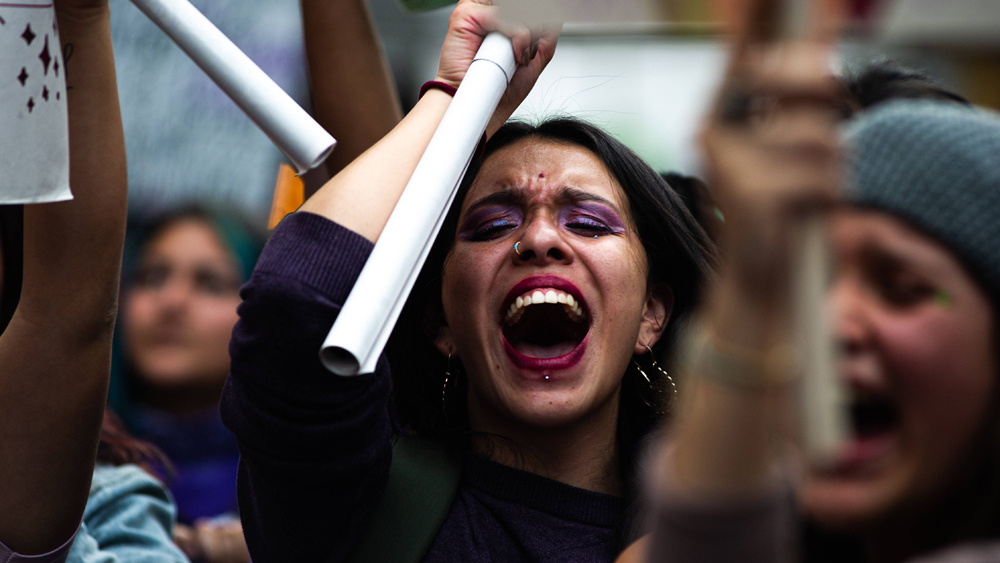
[302,0,403,176]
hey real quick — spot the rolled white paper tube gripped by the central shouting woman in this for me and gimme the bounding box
[320,33,516,376]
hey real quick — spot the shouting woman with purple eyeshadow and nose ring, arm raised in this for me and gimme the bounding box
[222,0,711,561]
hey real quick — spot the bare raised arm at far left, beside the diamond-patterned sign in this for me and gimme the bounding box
[0,0,127,554]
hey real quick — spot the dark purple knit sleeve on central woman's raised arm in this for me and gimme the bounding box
[222,212,392,561]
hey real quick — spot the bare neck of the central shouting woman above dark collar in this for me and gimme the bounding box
[469,394,621,495]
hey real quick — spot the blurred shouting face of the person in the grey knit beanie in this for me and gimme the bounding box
[803,209,997,531]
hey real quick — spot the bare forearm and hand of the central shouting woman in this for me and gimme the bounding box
[302,0,557,241]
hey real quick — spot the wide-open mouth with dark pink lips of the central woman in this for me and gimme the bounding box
[500,276,591,370]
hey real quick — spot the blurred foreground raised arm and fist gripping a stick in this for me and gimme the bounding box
[650,0,839,562]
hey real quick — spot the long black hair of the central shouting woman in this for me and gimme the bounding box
[386,118,715,546]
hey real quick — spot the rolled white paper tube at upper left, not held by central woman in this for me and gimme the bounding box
[132,0,337,174]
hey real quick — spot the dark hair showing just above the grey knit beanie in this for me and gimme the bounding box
[844,59,972,111]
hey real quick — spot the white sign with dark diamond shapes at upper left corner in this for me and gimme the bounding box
[0,0,73,203]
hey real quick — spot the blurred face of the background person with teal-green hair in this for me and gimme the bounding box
[123,218,243,398]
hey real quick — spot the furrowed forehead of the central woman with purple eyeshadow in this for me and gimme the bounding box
[463,137,627,208]
